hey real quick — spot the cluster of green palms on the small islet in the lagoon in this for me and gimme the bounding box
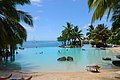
[57,22,83,45]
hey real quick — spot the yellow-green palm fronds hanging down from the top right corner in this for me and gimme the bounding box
[88,0,120,23]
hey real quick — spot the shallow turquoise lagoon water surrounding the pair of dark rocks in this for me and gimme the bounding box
[0,42,119,72]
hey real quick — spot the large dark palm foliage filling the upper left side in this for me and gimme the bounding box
[0,0,33,60]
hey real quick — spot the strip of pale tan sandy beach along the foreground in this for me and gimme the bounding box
[0,69,120,80]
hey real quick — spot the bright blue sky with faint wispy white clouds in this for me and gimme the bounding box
[17,0,111,41]
